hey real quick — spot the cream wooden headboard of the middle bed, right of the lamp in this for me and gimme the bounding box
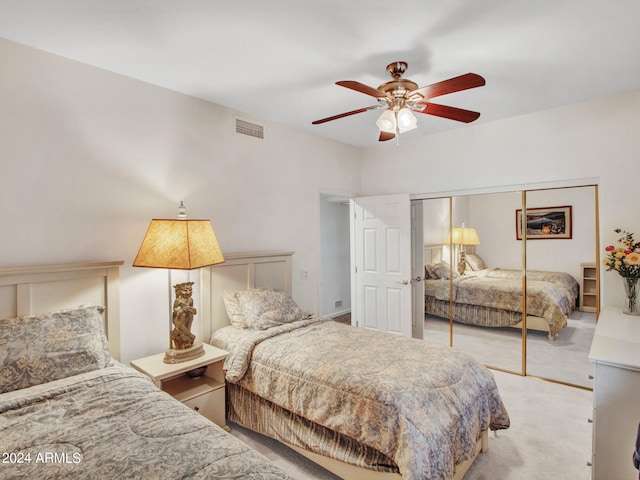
[200,252,294,343]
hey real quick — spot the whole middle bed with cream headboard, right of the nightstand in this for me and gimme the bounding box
[202,252,509,480]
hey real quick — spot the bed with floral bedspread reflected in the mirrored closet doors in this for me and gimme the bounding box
[424,254,579,340]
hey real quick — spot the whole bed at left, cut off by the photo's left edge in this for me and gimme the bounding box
[0,262,289,480]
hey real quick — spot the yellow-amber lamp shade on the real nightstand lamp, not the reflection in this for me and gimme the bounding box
[133,219,224,270]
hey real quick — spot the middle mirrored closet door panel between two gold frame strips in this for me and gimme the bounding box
[453,192,523,374]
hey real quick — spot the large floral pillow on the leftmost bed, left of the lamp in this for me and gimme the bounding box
[0,306,111,393]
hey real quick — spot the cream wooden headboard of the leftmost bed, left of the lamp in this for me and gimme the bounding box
[0,261,124,360]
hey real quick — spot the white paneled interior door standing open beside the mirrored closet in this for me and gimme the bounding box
[350,194,412,337]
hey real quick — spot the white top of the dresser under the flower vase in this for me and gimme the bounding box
[589,307,640,371]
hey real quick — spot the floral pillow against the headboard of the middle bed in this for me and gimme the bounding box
[234,290,306,330]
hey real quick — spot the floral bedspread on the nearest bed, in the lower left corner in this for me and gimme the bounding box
[0,364,292,480]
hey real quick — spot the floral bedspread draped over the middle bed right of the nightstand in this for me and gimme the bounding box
[211,319,509,480]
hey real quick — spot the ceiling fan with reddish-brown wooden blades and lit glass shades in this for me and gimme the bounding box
[312,62,486,142]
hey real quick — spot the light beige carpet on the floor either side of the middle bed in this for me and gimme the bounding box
[230,371,592,480]
